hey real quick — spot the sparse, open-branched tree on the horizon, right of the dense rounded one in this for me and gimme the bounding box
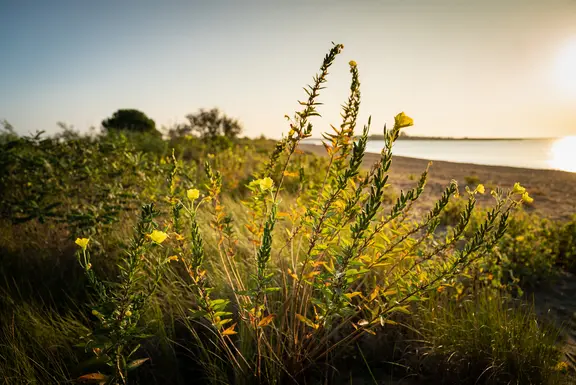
[175,108,242,140]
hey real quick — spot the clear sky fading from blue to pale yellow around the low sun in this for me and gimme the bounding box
[0,0,576,138]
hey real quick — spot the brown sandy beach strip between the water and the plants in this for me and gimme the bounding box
[300,144,576,219]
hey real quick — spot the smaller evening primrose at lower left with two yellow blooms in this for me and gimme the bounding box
[75,204,173,384]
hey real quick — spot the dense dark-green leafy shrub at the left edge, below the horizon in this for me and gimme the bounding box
[0,132,160,239]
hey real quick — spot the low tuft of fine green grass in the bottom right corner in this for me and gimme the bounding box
[416,291,560,384]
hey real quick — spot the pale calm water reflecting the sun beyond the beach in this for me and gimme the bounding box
[306,136,576,172]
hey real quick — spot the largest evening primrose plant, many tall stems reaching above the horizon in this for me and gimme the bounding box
[148,45,528,383]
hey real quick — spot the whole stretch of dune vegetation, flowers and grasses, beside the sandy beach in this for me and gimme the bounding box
[0,45,576,384]
